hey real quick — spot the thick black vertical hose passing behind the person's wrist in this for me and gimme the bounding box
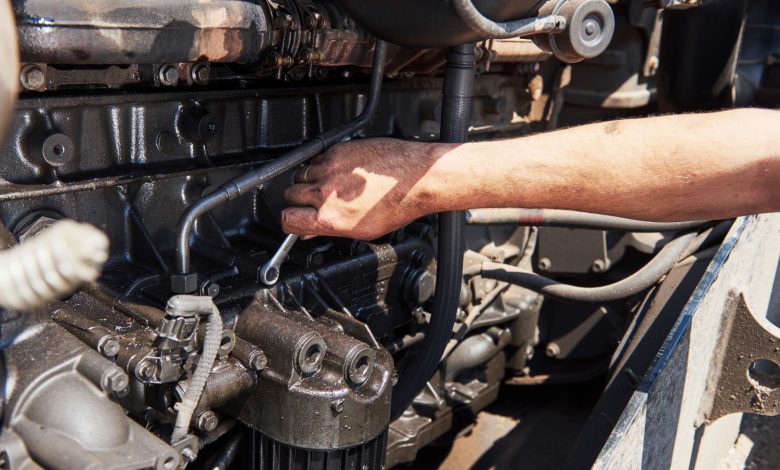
[391,44,475,419]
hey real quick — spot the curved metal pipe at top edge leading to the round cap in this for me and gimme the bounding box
[451,0,566,39]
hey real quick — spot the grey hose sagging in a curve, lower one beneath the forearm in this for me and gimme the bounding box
[479,233,696,302]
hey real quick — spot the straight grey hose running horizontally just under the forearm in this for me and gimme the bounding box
[466,209,707,232]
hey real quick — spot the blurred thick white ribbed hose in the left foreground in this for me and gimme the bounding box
[0,220,108,311]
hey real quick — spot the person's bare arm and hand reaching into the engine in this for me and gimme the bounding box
[282,109,780,240]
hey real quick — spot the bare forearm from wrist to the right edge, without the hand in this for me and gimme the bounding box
[420,109,780,220]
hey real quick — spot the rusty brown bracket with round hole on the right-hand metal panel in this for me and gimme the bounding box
[703,293,780,422]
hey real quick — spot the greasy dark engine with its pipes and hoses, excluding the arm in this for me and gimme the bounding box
[0,0,772,469]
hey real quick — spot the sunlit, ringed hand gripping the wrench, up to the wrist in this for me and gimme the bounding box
[282,139,444,240]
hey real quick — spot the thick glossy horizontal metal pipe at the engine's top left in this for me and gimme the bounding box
[13,0,272,64]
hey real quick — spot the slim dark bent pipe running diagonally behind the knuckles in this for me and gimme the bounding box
[171,39,387,293]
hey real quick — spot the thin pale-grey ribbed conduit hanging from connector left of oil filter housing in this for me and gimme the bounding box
[166,295,222,444]
